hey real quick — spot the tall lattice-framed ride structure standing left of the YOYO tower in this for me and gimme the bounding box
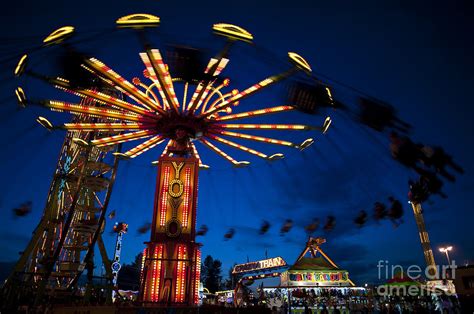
[4,106,117,293]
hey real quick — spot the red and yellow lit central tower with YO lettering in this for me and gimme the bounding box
[140,141,201,306]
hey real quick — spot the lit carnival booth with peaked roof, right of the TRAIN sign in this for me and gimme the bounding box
[263,238,370,313]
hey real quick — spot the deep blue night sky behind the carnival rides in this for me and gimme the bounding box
[0,0,474,284]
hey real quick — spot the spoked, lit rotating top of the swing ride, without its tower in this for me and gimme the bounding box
[17,14,332,168]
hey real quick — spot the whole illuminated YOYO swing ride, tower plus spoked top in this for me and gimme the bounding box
[12,14,332,306]
